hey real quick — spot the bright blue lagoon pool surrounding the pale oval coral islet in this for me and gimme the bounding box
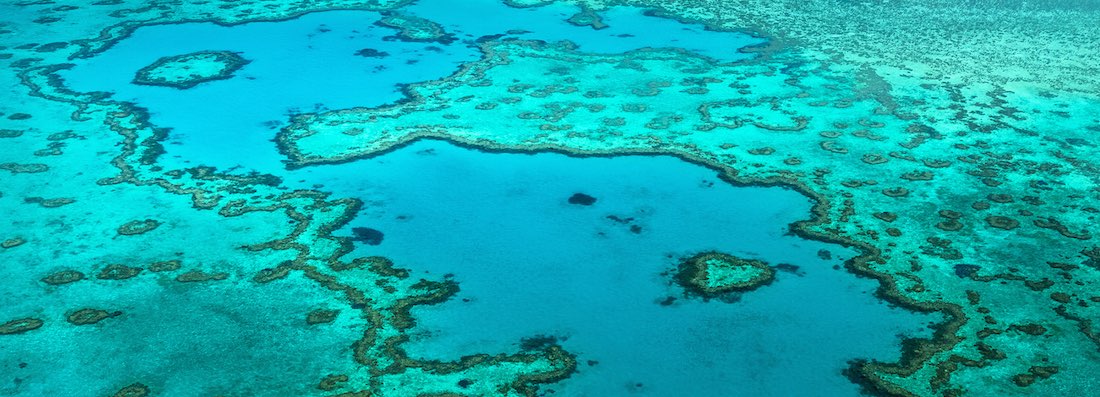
[63,11,476,173]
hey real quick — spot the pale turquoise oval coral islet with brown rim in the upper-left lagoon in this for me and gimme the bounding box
[133,51,249,89]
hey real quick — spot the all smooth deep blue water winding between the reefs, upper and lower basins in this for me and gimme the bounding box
[64,0,934,396]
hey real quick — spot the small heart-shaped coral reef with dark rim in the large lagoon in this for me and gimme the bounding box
[675,251,776,298]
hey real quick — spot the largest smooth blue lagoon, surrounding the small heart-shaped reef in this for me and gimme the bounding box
[323,141,935,396]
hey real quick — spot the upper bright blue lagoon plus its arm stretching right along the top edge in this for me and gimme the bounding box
[61,0,761,174]
